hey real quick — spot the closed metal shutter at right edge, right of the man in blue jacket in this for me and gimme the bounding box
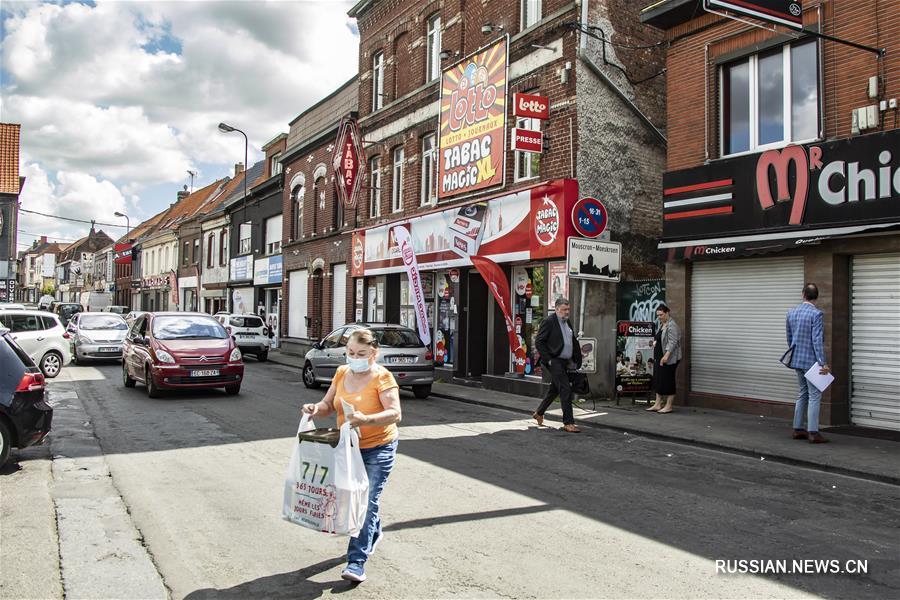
[850,254,900,431]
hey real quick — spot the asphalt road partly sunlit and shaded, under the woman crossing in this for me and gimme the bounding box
[0,359,900,599]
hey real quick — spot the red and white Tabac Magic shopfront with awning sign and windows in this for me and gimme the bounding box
[351,180,578,394]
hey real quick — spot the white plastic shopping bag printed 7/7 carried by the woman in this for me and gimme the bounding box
[281,415,369,537]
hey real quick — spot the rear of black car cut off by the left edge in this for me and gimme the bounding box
[0,329,53,467]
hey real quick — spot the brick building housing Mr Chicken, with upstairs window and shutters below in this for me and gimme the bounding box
[643,0,900,430]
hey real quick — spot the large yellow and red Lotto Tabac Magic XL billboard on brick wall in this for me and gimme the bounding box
[438,36,509,199]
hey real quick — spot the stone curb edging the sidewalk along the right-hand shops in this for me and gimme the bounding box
[431,391,900,487]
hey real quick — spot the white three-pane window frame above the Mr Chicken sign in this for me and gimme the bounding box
[719,41,822,158]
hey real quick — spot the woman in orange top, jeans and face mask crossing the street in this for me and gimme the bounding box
[303,329,401,583]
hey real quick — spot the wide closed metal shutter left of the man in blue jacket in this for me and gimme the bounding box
[691,258,803,403]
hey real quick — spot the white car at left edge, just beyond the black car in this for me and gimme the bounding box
[0,310,72,379]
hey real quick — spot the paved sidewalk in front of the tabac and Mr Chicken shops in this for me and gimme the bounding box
[269,352,900,485]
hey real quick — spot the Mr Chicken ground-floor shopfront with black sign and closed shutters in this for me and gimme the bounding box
[660,130,900,431]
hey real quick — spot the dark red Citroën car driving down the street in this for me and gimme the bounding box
[122,312,244,398]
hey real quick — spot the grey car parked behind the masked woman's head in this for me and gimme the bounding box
[303,323,434,398]
